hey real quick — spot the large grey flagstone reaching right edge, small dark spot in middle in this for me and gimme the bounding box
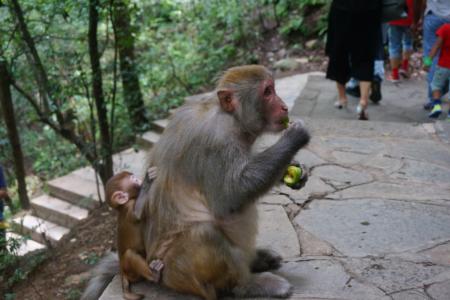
[294,199,450,257]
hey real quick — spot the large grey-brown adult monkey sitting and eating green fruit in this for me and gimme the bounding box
[136,65,310,299]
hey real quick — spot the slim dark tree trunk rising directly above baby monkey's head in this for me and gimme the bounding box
[88,0,113,184]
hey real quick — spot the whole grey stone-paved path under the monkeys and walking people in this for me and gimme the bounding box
[101,75,450,300]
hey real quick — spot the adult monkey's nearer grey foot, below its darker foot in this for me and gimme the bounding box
[233,272,293,298]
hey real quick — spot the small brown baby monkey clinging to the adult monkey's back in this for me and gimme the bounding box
[106,168,164,300]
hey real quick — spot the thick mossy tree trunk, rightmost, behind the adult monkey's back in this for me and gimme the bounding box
[112,0,148,131]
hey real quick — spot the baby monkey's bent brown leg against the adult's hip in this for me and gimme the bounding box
[123,249,163,282]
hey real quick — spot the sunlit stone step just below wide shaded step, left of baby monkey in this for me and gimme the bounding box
[31,195,89,228]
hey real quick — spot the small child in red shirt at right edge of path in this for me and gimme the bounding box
[424,23,450,120]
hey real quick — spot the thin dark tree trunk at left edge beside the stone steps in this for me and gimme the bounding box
[0,60,30,209]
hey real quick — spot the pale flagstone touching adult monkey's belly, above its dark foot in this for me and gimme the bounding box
[256,205,300,258]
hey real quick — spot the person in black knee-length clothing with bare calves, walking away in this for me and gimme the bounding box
[325,0,381,120]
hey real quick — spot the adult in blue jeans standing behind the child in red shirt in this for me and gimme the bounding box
[413,0,450,110]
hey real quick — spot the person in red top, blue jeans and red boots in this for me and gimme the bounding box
[388,0,414,82]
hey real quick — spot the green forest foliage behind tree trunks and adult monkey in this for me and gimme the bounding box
[0,0,329,202]
